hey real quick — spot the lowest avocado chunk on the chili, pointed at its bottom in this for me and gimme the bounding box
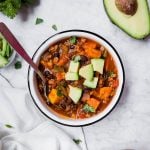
[69,85,82,104]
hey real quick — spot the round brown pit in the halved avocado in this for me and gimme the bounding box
[115,0,138,16]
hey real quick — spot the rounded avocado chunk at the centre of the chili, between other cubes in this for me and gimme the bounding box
[79,64,94,81]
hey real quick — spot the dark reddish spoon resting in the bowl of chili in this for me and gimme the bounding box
[0,22,48,100]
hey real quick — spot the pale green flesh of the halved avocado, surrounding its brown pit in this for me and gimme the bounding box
[103,0,150,39]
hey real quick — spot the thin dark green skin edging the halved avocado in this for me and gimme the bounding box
[103,0,150,40]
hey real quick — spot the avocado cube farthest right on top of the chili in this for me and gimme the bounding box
[91,58,105,74]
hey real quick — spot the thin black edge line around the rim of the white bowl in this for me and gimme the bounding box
[27,29,125,127]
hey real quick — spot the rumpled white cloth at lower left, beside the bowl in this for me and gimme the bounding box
[0,87,86,150]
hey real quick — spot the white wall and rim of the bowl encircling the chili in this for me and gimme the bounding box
[28,30,125,126]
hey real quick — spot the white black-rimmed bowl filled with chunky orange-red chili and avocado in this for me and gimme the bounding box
[28,30,125,126]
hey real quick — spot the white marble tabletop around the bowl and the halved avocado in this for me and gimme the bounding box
[0,0,150,150]
